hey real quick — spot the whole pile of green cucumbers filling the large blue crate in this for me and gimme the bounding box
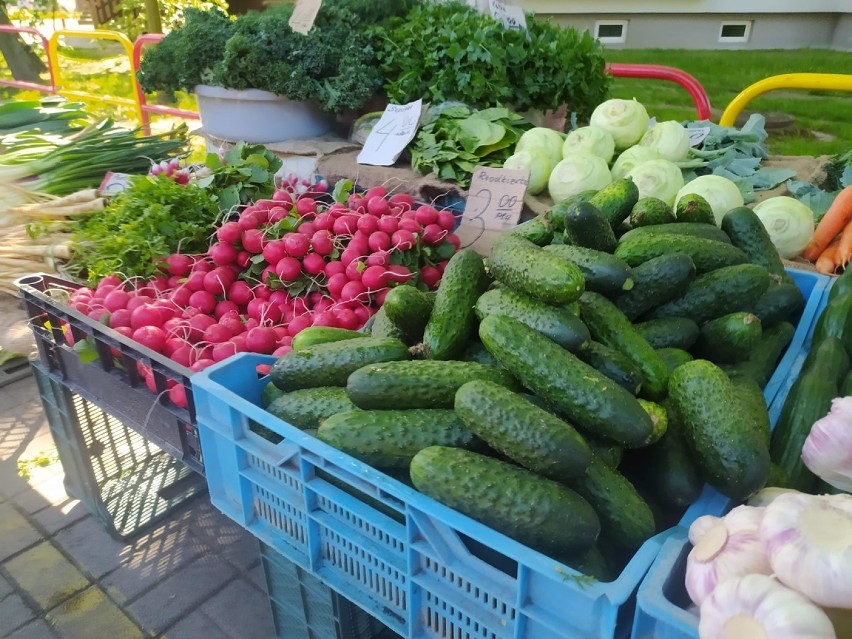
[264,179,805,580]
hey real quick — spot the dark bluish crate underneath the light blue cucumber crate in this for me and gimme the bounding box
[260,542,399,639]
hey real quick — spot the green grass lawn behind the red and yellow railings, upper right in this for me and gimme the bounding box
[606,49,852,155]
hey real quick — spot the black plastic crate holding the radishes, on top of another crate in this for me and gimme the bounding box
[15,273,204,474]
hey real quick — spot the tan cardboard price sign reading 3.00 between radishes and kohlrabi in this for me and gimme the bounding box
[456,166,530,256]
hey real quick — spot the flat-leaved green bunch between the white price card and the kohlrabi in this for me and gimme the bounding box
[411,105,532,188]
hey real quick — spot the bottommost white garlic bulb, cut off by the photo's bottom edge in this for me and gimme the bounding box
[698,575,837,639]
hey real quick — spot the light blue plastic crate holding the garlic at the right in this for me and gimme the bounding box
[632,271,832,639]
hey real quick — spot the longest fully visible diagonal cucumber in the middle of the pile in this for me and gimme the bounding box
[479,315,653,446]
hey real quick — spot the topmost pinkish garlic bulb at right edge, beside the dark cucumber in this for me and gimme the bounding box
[802,397,852,492]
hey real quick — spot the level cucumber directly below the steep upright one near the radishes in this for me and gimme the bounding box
[346,359,517,410]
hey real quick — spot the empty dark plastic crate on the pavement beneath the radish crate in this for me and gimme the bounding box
[32,362,207,541]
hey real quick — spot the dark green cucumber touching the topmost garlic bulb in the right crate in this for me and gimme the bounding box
[769,368,838,493]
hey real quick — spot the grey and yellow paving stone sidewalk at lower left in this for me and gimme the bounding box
[0,294,275,639]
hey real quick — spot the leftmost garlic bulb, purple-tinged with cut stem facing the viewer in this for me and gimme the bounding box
[686,506,772,605]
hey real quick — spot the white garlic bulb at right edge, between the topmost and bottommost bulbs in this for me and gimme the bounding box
[760,494,852,608]
